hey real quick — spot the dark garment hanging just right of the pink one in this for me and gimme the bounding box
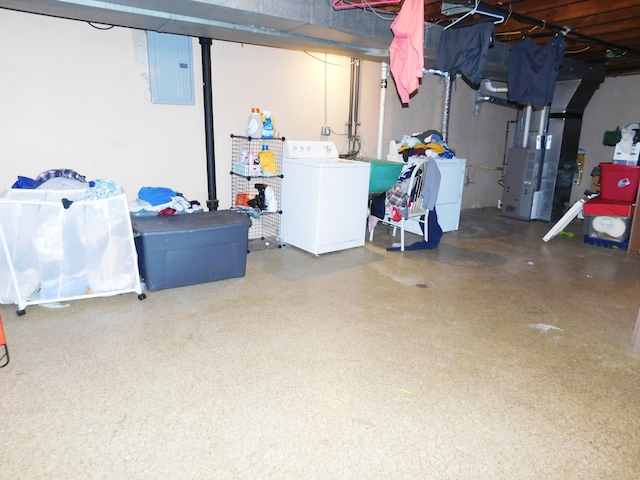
[434,22,493,85]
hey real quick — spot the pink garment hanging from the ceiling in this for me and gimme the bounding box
[389,0,424,103]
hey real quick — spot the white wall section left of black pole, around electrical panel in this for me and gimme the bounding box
[0,10,206,202]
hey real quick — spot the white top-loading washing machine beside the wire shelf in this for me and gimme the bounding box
[281,140,371,255]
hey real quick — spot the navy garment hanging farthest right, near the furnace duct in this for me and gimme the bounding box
[507,34,565,108]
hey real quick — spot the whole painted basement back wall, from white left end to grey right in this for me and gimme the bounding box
[0,10,556,213]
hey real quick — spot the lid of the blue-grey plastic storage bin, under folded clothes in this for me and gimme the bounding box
[131,210,251,235]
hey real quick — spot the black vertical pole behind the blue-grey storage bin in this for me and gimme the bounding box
[200,37,219,210]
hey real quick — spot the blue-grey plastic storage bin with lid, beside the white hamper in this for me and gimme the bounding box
[131,210,251,291]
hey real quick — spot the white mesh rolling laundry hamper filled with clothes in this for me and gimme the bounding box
[0,189,144,314]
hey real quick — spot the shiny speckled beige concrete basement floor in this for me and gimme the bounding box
[0,209,640,480]
